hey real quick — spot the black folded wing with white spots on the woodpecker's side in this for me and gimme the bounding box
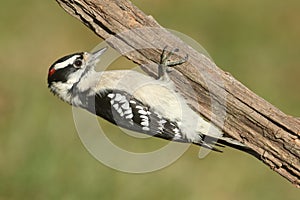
[86,90,188,142]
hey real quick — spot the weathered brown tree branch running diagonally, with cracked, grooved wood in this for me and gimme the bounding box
[56,0,300,187]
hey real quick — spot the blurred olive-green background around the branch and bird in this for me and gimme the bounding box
[0,0,300,200]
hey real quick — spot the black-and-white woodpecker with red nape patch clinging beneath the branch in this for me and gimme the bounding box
[48,47,250,152]
